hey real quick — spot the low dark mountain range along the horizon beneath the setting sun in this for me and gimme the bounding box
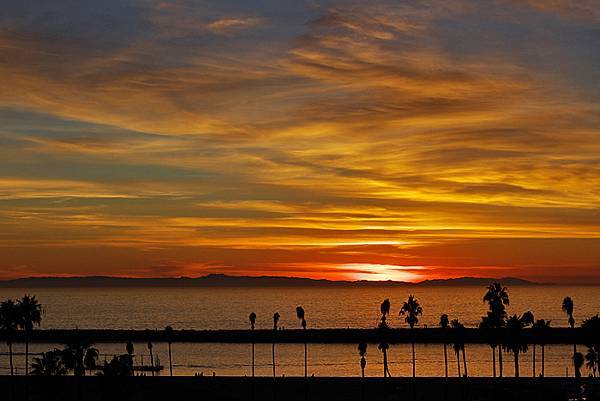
[0,274,538,288]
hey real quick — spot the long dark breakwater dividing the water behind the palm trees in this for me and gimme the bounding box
[0,328,600,344]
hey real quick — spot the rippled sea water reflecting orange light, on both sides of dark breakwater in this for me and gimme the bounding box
[0,286,600,376]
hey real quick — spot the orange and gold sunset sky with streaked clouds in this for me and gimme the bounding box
[0,0,600,283]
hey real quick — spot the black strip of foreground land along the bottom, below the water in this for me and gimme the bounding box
[0,376,600,401]
